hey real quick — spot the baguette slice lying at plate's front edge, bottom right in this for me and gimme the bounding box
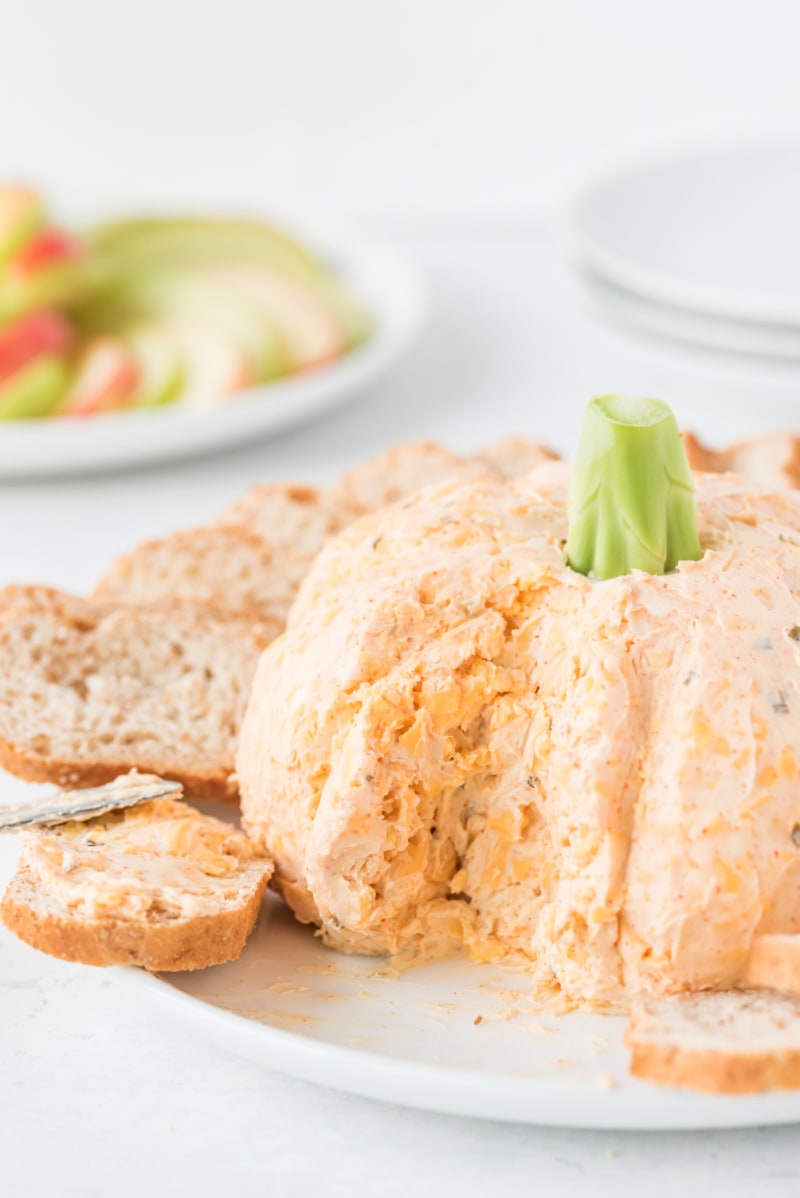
[625,991,800,1094]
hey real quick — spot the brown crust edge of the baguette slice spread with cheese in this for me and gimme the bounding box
[0,861,272,973]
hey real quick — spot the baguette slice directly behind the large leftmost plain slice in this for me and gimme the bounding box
[92,524,296,623]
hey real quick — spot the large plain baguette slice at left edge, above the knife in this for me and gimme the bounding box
[0,597,269,798]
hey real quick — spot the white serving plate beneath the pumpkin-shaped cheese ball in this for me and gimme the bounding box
[123,895,800,1129]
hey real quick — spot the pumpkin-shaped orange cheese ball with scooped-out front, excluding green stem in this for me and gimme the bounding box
[237,397,800,1003]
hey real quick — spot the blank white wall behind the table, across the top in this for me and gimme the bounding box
[0,0,800,223]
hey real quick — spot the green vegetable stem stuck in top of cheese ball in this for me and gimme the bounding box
[566,395,702,579]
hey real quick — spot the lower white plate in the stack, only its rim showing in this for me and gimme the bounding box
[575,267,800,365]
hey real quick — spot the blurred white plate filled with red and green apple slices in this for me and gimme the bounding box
[0,187,423,478]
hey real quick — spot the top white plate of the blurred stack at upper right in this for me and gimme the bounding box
[568,144,800,325]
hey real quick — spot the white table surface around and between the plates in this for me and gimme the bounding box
[0,234,800,1198]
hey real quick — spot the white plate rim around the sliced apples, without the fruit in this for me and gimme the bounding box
[0,216,424,478]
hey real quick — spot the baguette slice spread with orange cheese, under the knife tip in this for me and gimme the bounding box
[0,799,272,970]
